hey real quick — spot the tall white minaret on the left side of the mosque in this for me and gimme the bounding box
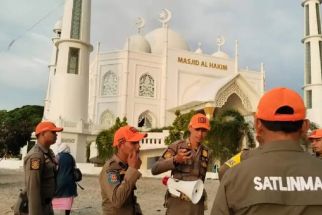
[44,0,92,161]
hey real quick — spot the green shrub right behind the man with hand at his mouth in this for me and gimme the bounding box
[96,117,127,161]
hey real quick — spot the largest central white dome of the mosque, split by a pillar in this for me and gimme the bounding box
[145,28,189,54]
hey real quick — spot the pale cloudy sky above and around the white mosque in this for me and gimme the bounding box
[0,0,304,110]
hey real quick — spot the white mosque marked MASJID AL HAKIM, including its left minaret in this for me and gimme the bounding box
[44,0,265,165]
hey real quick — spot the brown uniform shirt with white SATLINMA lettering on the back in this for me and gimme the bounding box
[211,141,322,215]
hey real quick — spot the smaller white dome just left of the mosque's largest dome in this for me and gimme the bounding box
[124,34,151,53]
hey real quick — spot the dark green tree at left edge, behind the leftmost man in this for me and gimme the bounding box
[0,105,44,156]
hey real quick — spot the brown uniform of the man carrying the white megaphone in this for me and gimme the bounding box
[151,139,209,215]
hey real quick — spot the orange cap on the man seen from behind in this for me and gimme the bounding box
[256,87,305,122]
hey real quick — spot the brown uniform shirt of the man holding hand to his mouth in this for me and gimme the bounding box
[99,155,141,215]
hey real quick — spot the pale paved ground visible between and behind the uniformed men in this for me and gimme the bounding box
[0,169,219,215]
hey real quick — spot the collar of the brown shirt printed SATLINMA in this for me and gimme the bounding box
[262,140,303,153]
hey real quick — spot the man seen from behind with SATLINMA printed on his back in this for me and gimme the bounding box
[211,88,322,215]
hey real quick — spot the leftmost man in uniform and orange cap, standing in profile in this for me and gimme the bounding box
[24,121,63,215]
